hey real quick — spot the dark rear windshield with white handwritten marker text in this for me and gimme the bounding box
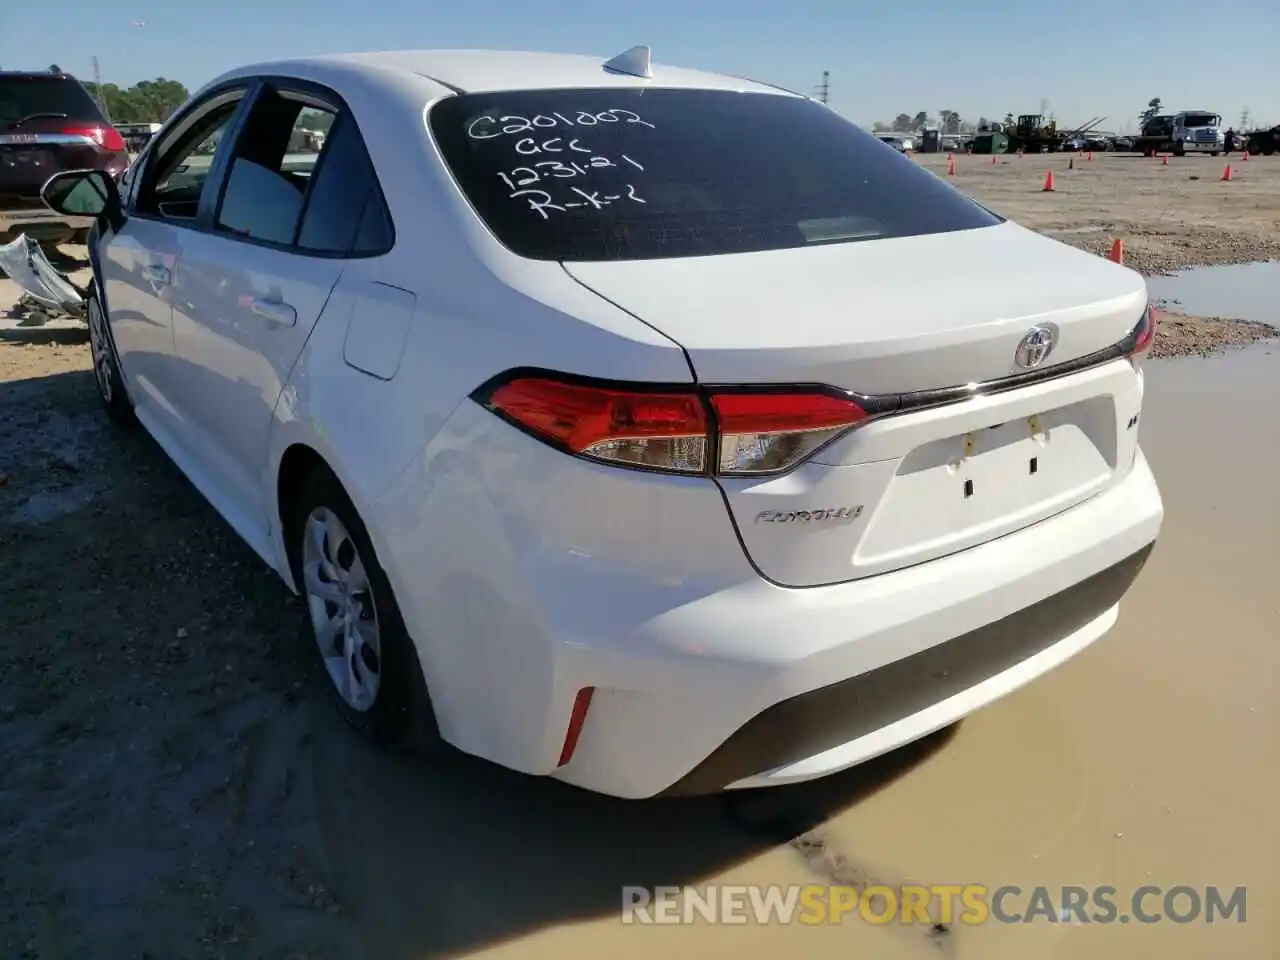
[430,90,1001,261]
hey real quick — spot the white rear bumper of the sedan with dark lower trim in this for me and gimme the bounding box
[369,394,1164,799]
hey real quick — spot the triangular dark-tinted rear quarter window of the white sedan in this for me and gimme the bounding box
[297,114,390,253]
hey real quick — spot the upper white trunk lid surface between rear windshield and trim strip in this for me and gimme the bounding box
[564,223,1147,393]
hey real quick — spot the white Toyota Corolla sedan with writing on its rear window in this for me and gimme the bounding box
[37,47,1162,797]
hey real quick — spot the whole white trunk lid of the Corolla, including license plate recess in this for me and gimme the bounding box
[564,224,1147,586]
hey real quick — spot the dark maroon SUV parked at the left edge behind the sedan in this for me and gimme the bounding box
[0,70,129,243]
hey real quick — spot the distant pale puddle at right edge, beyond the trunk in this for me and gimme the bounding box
[1147,260,1280,326]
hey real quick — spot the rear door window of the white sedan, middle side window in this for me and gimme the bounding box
[215,90,334,244]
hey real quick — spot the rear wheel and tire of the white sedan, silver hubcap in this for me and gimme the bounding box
[289,468,443,754]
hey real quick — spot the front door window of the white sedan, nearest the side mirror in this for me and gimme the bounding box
[133,92,243,221]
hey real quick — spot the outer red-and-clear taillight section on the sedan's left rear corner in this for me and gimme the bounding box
[488,378,707,474]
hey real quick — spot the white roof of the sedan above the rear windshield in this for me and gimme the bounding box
[218,50,799,96]
